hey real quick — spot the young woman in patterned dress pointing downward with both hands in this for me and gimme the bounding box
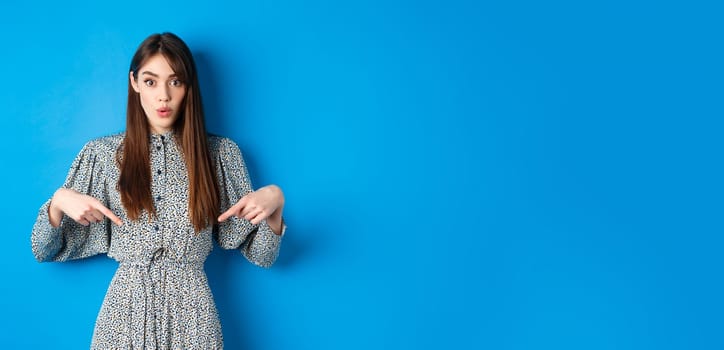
[31,33,286,349]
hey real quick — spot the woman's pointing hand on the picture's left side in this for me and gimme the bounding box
[48,188,123,227]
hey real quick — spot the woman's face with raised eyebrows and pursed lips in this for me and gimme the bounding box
[130,54,186,134]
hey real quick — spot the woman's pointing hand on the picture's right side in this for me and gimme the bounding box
[218,185,284,225]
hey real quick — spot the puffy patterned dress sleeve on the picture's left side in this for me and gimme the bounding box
[30,142,111,262]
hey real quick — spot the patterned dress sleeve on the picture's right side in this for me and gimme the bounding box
[214,138,286,267]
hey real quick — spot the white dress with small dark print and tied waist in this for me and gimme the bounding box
[31,132,286,349]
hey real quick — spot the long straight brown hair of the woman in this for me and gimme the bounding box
[118,33,219,232]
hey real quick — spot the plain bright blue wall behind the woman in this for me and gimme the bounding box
[0,0,724,349]
